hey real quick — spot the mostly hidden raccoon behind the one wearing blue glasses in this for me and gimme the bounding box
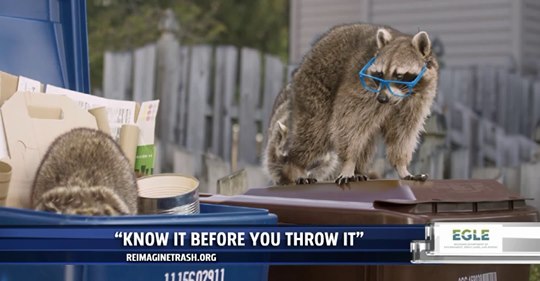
[263,84,338,185]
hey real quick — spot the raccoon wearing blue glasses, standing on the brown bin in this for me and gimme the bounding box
[266,24,438,185]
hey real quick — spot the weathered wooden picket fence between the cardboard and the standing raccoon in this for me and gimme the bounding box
[103,25,287,190]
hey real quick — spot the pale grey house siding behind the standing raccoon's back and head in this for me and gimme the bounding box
[290,0,540,69]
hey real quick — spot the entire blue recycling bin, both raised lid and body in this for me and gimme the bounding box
[0,0,277,281]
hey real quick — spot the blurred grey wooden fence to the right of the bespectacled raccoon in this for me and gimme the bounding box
[439,66,540,171]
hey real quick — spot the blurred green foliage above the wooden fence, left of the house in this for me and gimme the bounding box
[87,0,289,91]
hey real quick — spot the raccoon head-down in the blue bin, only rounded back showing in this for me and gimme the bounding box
[32,128,138,215]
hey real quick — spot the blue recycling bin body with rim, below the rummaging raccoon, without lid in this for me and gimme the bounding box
[0,204,277,281]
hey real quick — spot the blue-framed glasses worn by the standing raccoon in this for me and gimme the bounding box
[358,56,427,98]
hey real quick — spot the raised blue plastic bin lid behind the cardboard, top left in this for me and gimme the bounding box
[0,0,90,93]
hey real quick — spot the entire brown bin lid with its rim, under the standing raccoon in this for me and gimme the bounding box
[201,180,538,224]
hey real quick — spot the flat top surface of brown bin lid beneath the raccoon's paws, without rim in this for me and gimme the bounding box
[245,180,526,202]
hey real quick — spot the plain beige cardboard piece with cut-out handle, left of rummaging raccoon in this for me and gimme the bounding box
[0,92,97,208]
